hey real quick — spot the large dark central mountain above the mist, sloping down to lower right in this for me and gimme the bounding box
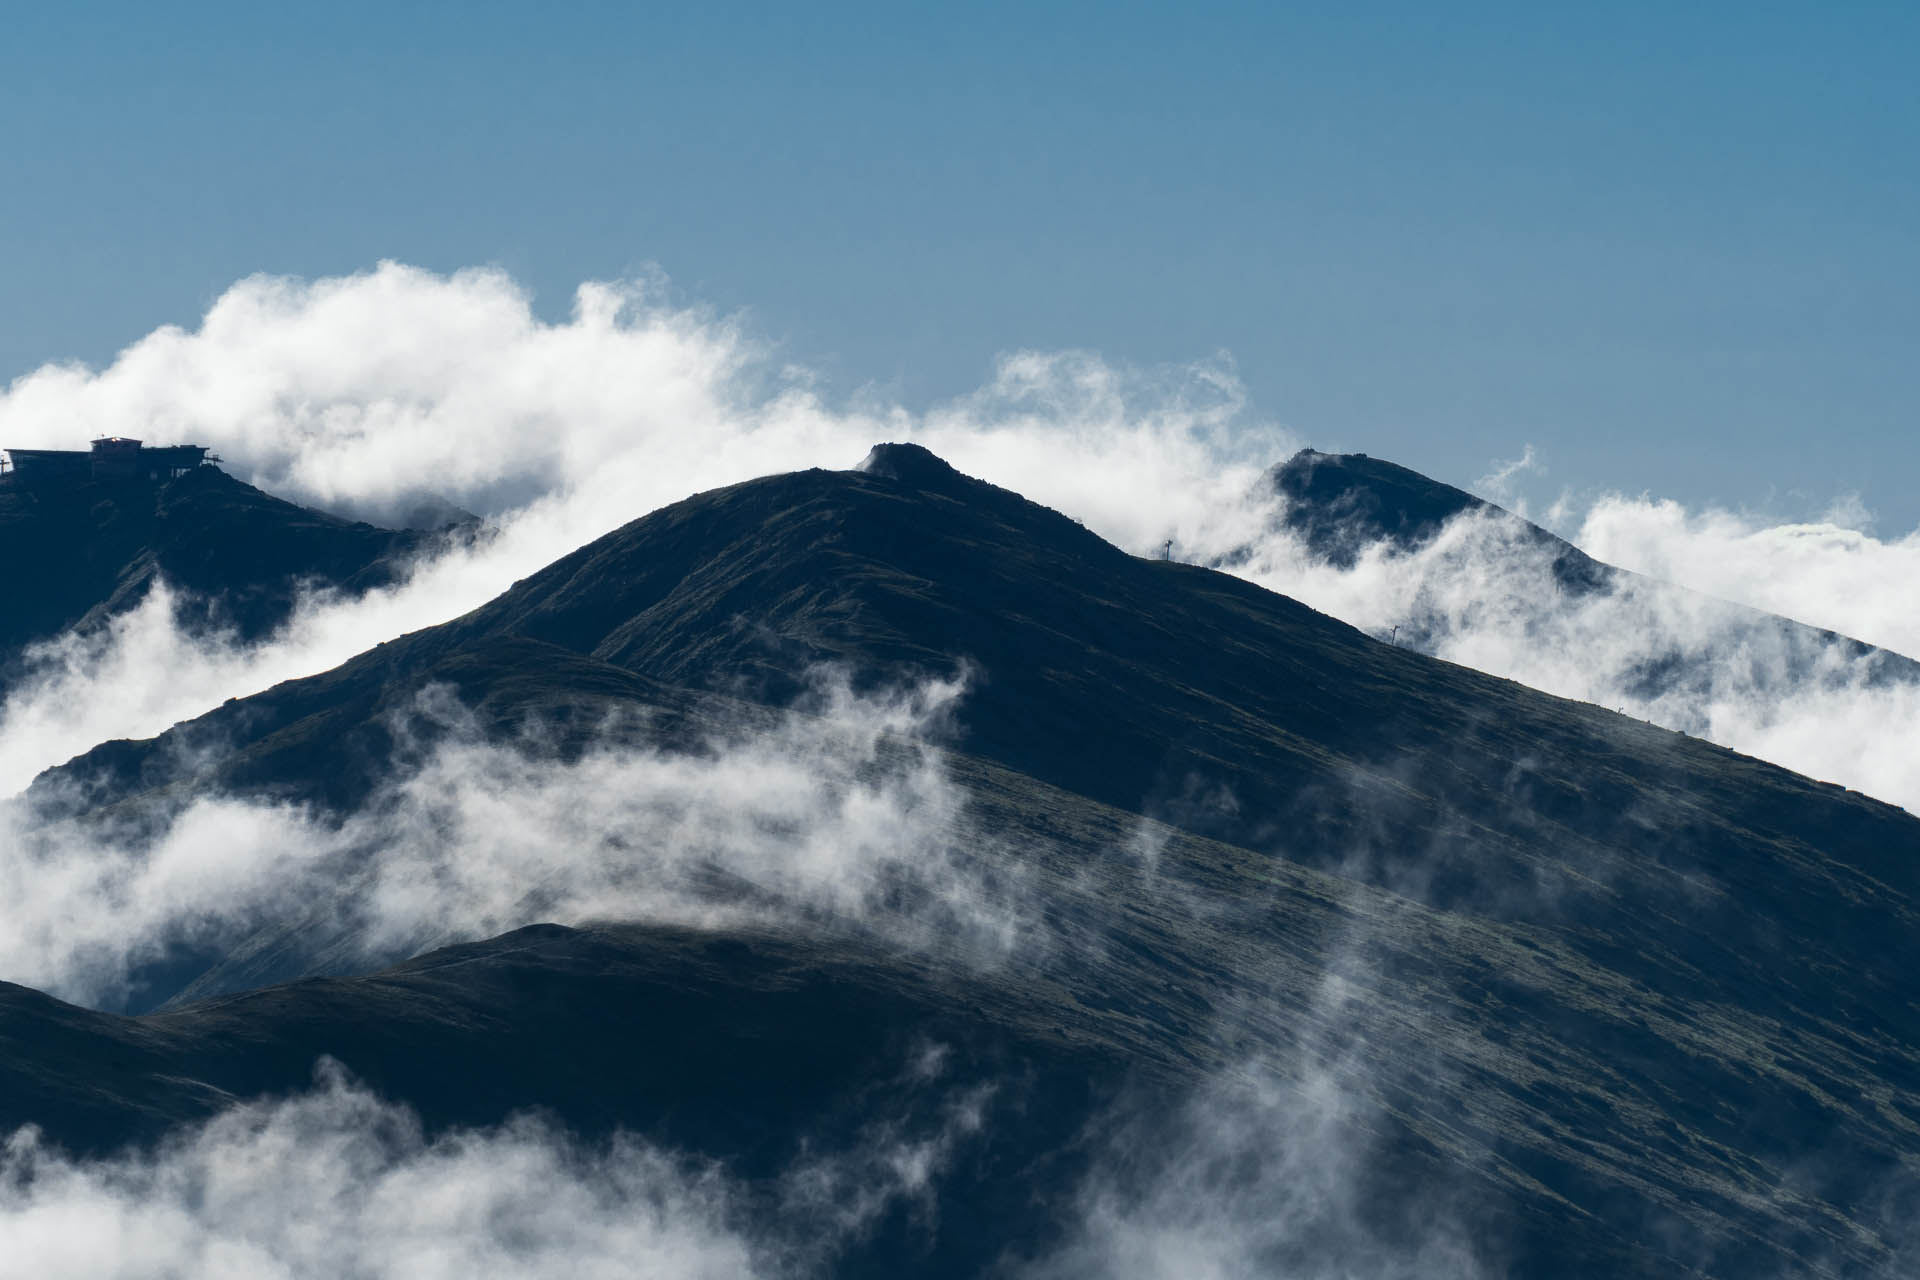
[22,447,1920,1276]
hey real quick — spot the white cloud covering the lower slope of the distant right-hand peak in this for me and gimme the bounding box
[1235,499,1920,812]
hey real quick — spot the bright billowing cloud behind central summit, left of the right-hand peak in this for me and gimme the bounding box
[0,263,1288,793]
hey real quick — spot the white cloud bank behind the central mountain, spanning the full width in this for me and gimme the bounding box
[0,263,1920,806]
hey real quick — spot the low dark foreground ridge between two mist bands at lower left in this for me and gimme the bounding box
[0,925,1121,1276]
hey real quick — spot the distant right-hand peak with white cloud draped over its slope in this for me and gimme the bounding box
[1219,451,1920,808]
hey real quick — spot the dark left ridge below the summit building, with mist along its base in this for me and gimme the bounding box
[0,466,488,794]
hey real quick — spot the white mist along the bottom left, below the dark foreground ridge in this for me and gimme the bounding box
[0,1063,987,1280]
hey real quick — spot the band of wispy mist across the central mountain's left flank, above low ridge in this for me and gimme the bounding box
[0,679,1023,1007]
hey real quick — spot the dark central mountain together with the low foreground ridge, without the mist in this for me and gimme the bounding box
[0,445,1920,1276]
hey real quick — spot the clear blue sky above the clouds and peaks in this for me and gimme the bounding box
[0,0,1920,533]
